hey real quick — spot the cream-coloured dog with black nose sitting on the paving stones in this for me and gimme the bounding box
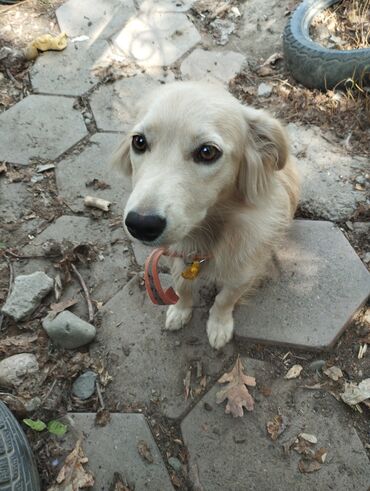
[113,82,299,349]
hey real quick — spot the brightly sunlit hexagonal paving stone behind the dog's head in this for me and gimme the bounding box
[113,12,201,66]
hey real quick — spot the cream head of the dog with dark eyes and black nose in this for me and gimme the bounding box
[113,82,288,245]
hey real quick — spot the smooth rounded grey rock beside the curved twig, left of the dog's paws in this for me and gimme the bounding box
[42,310,96,349]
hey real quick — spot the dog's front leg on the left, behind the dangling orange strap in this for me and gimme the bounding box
[165,260,193,331]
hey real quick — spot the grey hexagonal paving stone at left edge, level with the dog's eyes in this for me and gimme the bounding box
[0,95,87,165]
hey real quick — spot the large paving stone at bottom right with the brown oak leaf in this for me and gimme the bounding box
[181,359,370,491]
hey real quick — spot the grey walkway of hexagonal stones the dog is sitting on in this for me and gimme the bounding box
[0,0,370,491]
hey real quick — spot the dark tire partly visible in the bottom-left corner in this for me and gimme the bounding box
[0,401,41,491]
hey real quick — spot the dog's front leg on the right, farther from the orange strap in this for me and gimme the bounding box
[207,284,248,349]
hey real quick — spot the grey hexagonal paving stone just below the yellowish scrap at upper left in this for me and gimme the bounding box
[31,41,111,96]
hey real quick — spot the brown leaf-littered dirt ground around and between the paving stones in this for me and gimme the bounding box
[0,0,370,489]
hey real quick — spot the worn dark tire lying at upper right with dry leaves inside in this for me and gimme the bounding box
[283,0,370,90]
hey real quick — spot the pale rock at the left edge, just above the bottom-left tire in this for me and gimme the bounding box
[0,353,39,387]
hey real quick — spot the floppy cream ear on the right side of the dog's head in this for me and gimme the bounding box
[237,107,289,203]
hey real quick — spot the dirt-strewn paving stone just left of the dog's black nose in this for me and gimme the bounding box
[18,215,131,317]
